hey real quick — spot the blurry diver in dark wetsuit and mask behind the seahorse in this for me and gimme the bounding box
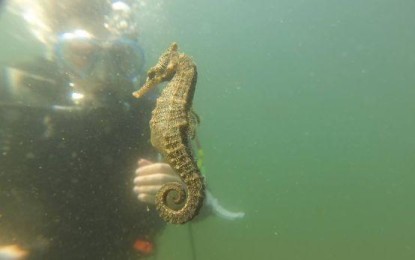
[0,0,243,259]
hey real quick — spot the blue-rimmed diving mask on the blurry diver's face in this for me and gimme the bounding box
[55,30,144,82]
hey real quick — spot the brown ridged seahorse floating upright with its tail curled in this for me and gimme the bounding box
[133,43,205,224]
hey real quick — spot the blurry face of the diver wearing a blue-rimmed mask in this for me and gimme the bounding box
[55,31,144,105]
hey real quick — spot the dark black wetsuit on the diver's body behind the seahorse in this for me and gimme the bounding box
[0,58,163,259]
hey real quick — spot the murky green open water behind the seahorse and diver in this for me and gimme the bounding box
[0,0,415,260]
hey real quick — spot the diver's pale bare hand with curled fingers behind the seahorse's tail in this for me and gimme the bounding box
[133,159,182,204]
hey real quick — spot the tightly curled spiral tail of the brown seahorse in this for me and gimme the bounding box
[156,174,205,224]
